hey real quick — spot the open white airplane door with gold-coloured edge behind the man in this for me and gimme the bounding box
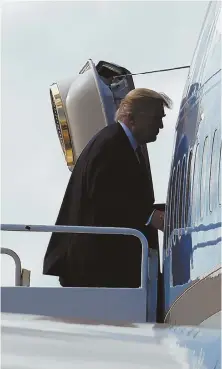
[50,60,135,171]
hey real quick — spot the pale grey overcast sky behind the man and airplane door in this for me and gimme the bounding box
[1,1,208,286]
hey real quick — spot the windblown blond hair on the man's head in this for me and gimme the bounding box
[115,88,172,121]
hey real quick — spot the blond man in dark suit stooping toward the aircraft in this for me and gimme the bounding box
[43,89,171,288]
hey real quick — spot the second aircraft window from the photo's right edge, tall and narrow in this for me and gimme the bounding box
[200,137,208,218]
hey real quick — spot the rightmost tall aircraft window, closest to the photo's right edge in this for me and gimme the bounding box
[209,130,218,212]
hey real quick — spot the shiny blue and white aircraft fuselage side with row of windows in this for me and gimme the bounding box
[164,2,221,313]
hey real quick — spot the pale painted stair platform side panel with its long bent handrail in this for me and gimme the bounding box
[1,224,158,322]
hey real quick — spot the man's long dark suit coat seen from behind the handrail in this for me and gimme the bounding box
[44,124,154,287]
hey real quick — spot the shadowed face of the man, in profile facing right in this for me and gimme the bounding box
[132,102,165,144]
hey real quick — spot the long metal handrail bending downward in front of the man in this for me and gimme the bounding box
[1,224,149,291]
